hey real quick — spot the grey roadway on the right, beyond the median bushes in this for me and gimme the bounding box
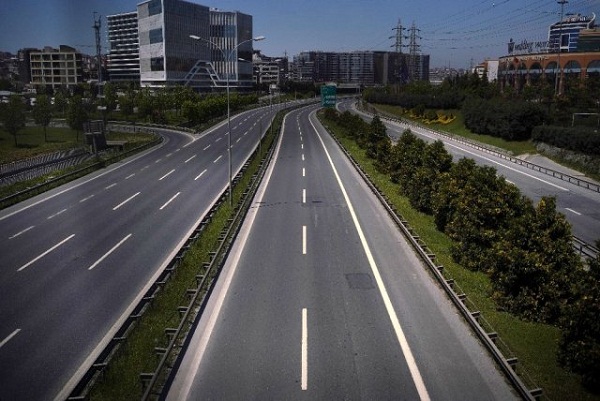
[343,102,600,245]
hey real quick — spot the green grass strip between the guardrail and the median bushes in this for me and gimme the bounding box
[321,109,600,400]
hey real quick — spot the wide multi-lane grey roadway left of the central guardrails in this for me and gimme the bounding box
[0,102,288,401]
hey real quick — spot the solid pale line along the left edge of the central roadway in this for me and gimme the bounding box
[166,109,287,401]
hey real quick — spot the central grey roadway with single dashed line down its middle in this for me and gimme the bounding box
[167,104,516,400]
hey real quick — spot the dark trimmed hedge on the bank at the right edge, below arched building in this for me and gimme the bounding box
[532,125,600,155]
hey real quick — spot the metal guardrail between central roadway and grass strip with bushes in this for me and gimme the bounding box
[324,120,543,401]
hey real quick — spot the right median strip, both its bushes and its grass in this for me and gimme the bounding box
[321,109,600,400]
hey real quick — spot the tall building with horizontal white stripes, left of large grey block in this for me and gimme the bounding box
[106,11,140,82]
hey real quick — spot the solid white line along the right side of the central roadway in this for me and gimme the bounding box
[309,112,430,401]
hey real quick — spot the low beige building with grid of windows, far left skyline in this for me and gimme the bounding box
[29,45,83,89]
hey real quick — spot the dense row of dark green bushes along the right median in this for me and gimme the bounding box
[325,110,600,388]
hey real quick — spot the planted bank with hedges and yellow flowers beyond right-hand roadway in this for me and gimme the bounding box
[364,74,600,180]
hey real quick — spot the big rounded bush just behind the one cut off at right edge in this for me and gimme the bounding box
[490,197,582,324]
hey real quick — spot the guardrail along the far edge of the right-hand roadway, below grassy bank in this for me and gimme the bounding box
[362,103,600,193]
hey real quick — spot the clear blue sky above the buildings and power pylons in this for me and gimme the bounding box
[0,0,600,68]
